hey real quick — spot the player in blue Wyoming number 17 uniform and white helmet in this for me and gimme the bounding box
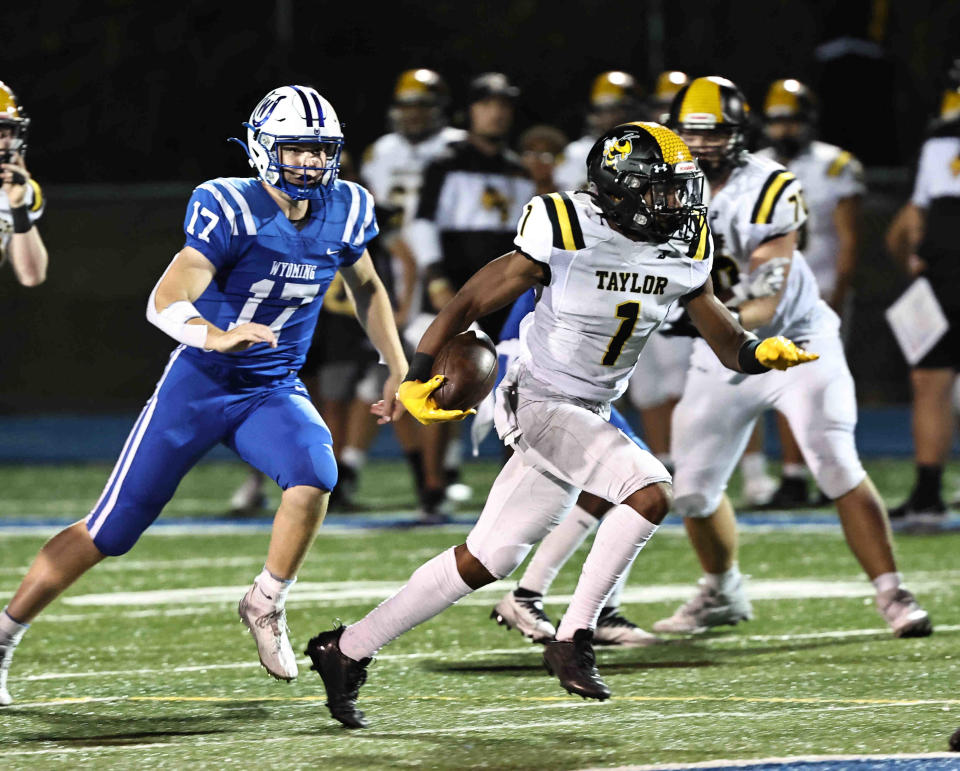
[0,86,407,705]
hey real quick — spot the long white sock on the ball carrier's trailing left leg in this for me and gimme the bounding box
[340,547,473,661]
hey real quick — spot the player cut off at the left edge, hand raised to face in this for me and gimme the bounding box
[0,81,48,286]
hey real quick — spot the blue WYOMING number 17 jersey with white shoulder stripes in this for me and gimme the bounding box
[183,177,379,378]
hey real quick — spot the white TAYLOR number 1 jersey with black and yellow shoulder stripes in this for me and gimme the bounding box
[514,192,713,408]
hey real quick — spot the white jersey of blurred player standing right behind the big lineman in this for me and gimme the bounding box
[758,142,866,297]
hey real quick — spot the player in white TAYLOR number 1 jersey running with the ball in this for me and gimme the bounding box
[306,123,816,728]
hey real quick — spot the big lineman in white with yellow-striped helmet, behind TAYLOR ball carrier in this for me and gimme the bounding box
[653,77,932,637]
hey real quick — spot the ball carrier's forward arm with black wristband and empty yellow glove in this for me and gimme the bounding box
[687,278,819,375]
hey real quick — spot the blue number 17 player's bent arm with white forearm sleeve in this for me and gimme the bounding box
[147,246,277,353]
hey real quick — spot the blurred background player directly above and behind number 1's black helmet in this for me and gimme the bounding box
[553,70,643,190]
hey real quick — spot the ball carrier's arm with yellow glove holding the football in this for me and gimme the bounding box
[398,252,549,423]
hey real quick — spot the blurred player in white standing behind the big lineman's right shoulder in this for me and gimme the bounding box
[759,78,866,508]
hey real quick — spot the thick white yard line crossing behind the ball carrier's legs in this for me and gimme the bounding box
[56,576,960,607]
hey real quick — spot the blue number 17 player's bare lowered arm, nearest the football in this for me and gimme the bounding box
[340,252,407,423]
